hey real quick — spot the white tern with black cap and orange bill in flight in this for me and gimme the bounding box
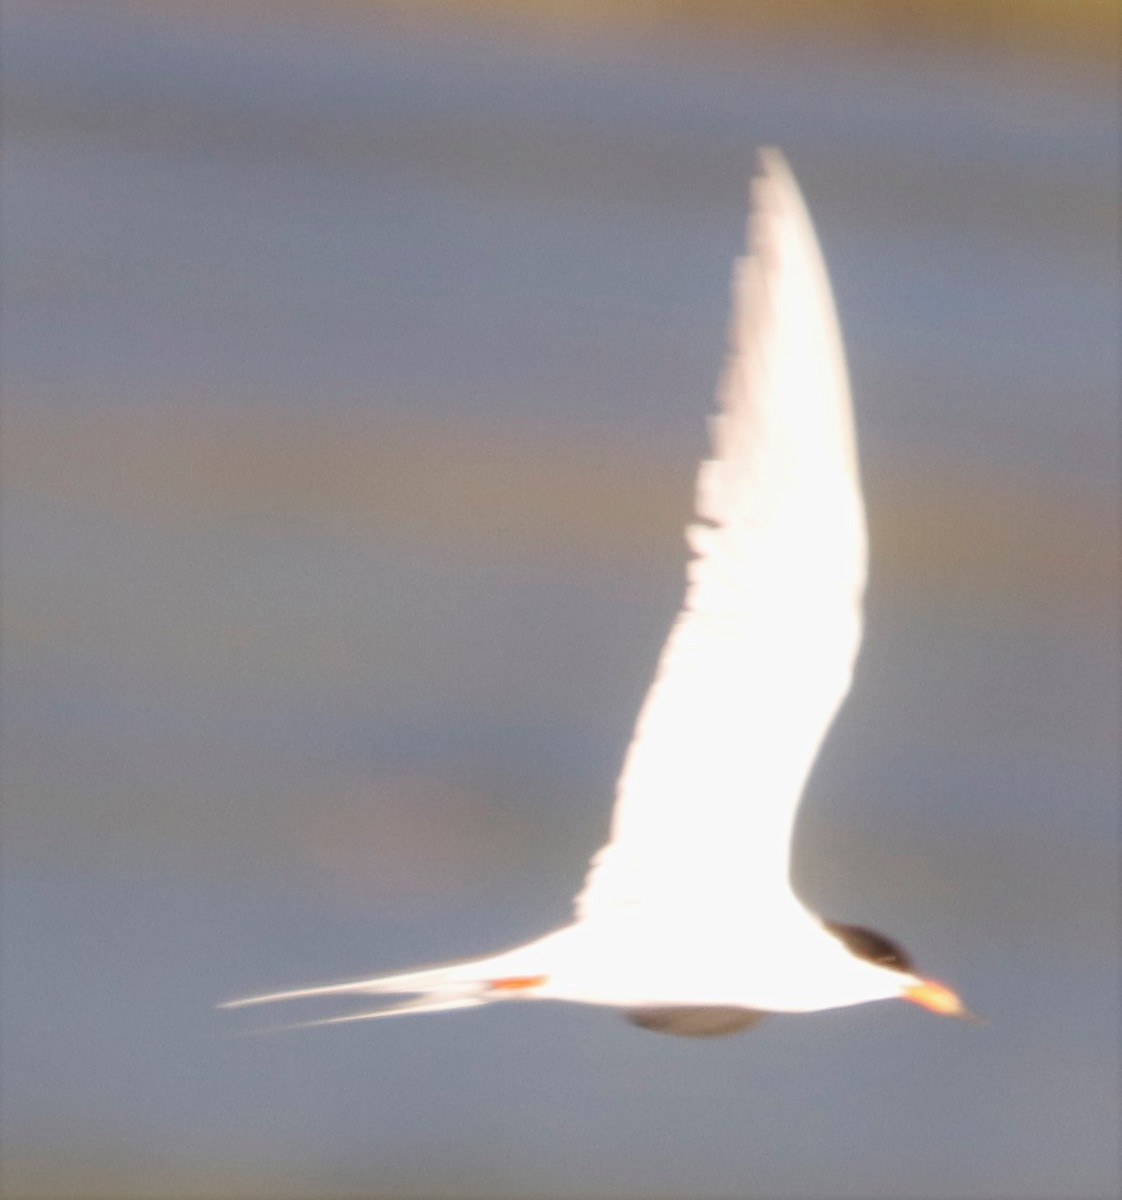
[222,150,972,1036]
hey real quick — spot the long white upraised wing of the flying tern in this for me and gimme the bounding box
[576,150,865,920]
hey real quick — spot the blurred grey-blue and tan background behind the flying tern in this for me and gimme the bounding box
[2,0,1120,1200]
